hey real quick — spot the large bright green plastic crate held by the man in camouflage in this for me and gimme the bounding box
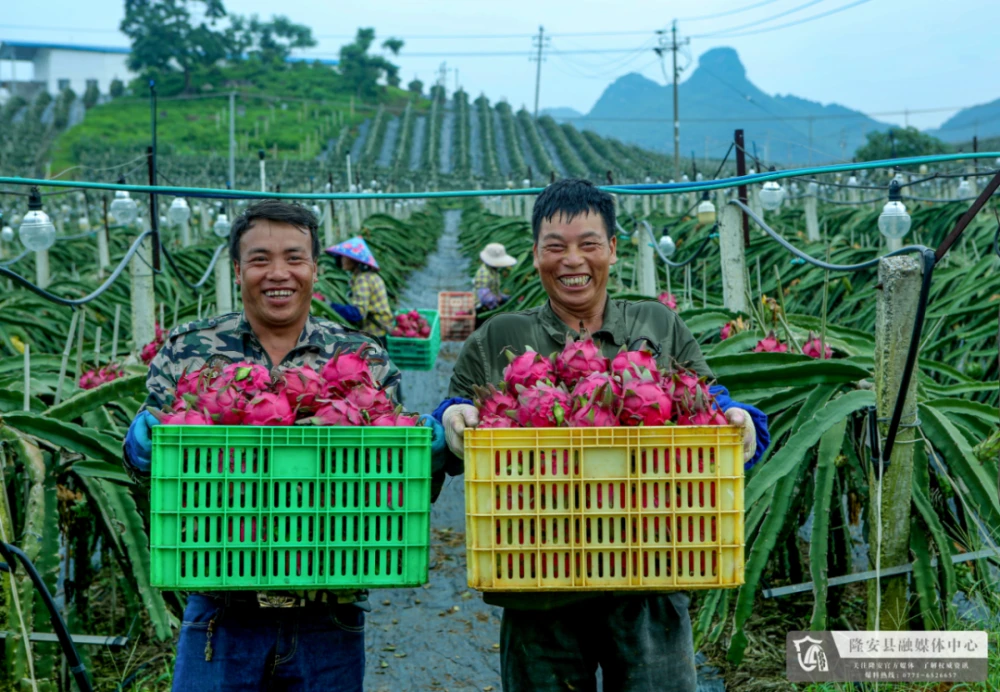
[150,425,431,591]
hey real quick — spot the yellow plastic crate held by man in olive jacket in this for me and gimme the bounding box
[465,426,745,591]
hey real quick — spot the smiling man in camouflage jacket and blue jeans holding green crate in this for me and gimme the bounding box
[125,200,443,692]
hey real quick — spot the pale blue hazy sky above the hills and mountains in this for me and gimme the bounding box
[0,0,1000,127]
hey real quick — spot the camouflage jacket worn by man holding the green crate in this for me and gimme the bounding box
[123,312,399,603]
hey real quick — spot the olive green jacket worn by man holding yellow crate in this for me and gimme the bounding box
[448,297,712,610]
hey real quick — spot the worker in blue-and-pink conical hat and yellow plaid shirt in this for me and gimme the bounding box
[326,236,392,345]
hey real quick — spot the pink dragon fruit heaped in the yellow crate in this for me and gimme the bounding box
[476,335,728,428]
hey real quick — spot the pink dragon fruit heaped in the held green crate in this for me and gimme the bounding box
[160,346,418,427]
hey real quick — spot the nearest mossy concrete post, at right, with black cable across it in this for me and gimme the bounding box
[868,257,922,631]
